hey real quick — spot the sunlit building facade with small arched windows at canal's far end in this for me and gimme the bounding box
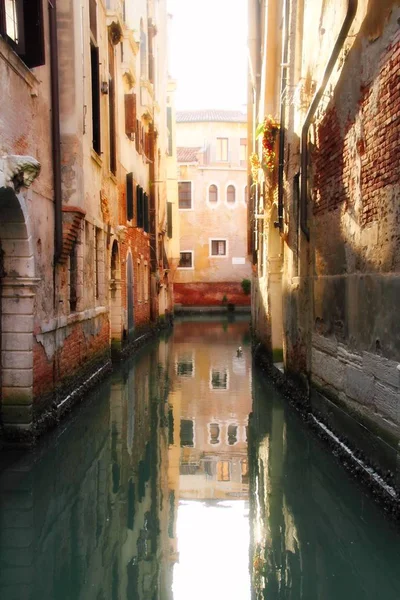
[174,110,251,307]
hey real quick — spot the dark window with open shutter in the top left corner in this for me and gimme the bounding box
[0,0,45,69]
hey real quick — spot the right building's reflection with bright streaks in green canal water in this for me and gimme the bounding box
[249,373,400,600]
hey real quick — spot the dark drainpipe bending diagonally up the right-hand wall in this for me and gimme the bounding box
[300,0,358,241]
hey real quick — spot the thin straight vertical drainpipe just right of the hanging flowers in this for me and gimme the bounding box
[274,0,289,232]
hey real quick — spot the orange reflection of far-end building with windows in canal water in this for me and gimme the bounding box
[173,319,251,500]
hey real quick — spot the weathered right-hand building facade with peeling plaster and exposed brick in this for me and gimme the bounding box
[249,0,400,487]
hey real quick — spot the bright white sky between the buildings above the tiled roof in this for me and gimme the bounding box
[167,0,247,110]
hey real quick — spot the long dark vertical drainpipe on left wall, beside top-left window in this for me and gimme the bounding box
[48,0,62,263]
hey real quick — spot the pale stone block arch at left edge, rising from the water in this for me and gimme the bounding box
[0,186,38,430]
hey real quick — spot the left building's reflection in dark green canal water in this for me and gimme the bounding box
[0,351,168,600]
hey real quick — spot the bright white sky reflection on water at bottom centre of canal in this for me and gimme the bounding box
[173,500,250,600]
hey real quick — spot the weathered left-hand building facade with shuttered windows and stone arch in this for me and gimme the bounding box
[0,0,173,441]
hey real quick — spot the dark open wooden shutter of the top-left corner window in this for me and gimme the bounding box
[19,0,47,69]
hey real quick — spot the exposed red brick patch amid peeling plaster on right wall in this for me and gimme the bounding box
[313,34,400,227]
